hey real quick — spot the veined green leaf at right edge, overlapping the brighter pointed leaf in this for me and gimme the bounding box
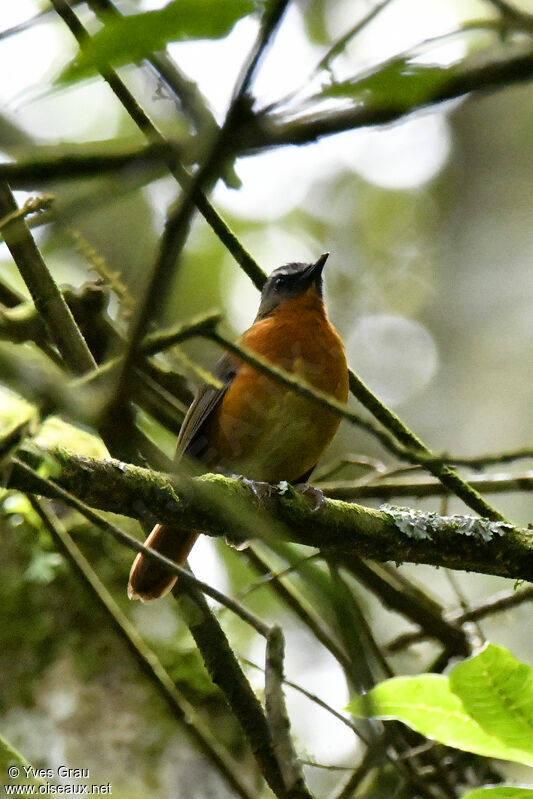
[450,644,533,761]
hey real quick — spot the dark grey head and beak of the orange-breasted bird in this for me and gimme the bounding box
[256,252,329,319]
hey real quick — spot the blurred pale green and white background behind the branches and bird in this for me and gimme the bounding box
[0,0,533,799]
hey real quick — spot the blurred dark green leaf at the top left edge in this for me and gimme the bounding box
[59,0,256,83]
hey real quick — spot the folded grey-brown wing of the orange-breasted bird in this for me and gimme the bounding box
[176,353,240,461]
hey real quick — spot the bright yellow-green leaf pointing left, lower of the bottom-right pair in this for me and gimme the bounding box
[348,674,533,765]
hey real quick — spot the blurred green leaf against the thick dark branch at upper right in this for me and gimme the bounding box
[320,58,453,109]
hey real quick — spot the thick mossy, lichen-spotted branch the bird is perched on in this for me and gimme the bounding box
[7,450,533,580]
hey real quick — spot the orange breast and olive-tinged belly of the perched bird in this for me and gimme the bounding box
[202,289,348,482]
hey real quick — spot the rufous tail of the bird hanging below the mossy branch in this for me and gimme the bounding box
[128,524,198,602]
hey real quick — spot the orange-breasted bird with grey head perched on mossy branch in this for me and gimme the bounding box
[128,253,348,601]
